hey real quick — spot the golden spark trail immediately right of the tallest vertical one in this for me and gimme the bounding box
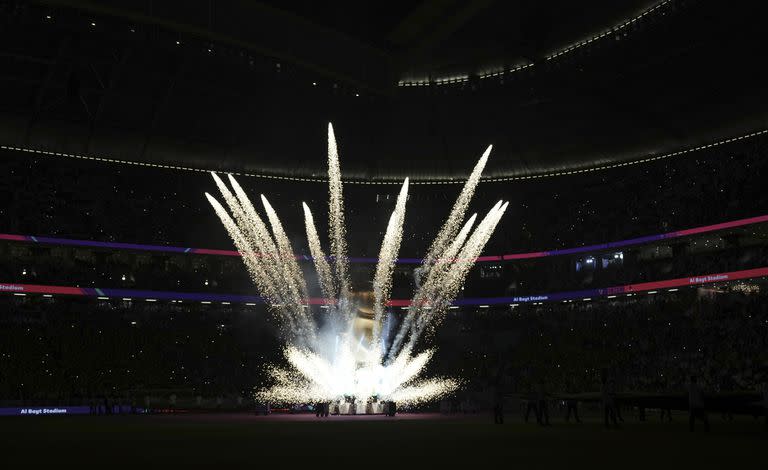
[373,178,408,345]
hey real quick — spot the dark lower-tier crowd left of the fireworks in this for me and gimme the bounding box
[0,295,280,403]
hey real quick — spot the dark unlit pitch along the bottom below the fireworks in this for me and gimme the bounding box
[0,413,768,469]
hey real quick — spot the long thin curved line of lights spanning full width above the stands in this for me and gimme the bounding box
[0,129,768,185]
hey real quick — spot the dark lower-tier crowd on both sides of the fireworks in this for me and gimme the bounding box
[0,284,768,403]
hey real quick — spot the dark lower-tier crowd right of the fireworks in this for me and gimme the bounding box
[438,285,768,396]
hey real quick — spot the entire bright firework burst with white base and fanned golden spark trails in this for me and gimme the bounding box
[205,124,508,412]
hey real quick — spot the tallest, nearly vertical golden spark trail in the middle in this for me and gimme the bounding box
[328,123,349,297]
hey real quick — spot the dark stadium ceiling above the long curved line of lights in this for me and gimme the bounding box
[0,0,768,181]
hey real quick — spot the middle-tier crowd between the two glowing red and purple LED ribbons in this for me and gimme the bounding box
[0,228,768,298]
